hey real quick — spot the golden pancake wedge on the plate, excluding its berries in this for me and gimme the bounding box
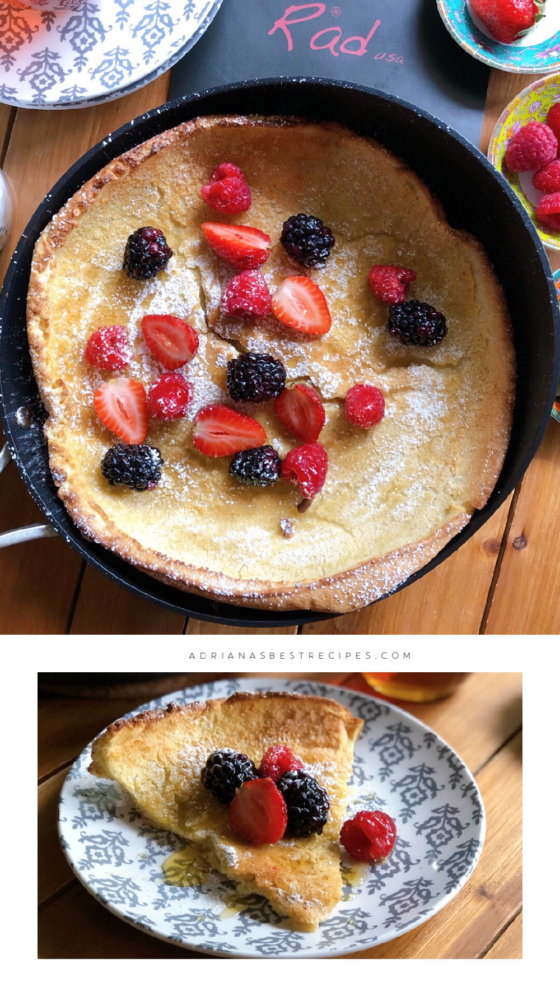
[89,692,363,930]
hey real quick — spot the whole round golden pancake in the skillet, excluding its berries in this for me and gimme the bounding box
[28,117,515,612]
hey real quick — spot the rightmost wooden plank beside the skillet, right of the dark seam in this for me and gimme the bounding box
[486,419,560,634]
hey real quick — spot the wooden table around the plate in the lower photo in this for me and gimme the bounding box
[39,672,522,958]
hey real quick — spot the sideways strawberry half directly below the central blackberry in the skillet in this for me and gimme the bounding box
[193,405,266,457]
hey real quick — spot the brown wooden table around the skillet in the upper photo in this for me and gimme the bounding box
[0,71,560,634]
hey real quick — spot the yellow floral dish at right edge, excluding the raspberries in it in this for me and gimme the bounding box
[488,73,560,250]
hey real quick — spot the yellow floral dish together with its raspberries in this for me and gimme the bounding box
[488,73,560,250]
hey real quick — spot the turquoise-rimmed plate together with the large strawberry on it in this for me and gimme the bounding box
[437,0,560,73]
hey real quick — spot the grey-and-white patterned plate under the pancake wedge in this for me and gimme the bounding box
[59,678,486,958]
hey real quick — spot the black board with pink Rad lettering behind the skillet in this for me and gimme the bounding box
[170,0,488,145]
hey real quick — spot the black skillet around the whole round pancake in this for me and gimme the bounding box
[0,78,560,627]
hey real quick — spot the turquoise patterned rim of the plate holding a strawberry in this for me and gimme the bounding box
[437,0,560,73]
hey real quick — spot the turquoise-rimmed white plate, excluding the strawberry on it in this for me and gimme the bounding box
[437,0,560,74]
